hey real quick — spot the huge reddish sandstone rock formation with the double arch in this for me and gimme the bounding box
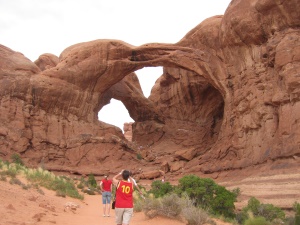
[0,0,300,179]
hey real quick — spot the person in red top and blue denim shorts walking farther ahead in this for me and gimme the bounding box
[100,175,112,217]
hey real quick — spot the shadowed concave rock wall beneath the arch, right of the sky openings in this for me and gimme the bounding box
[132,67,224,152]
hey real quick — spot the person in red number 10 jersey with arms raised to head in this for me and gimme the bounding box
[113,170,133,225]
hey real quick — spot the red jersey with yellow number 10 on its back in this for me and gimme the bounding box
[116,180,133,208]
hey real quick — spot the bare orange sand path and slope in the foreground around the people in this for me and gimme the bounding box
[0,181,195,225]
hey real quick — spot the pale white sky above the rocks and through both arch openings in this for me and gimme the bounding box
[0,0,231,132]
